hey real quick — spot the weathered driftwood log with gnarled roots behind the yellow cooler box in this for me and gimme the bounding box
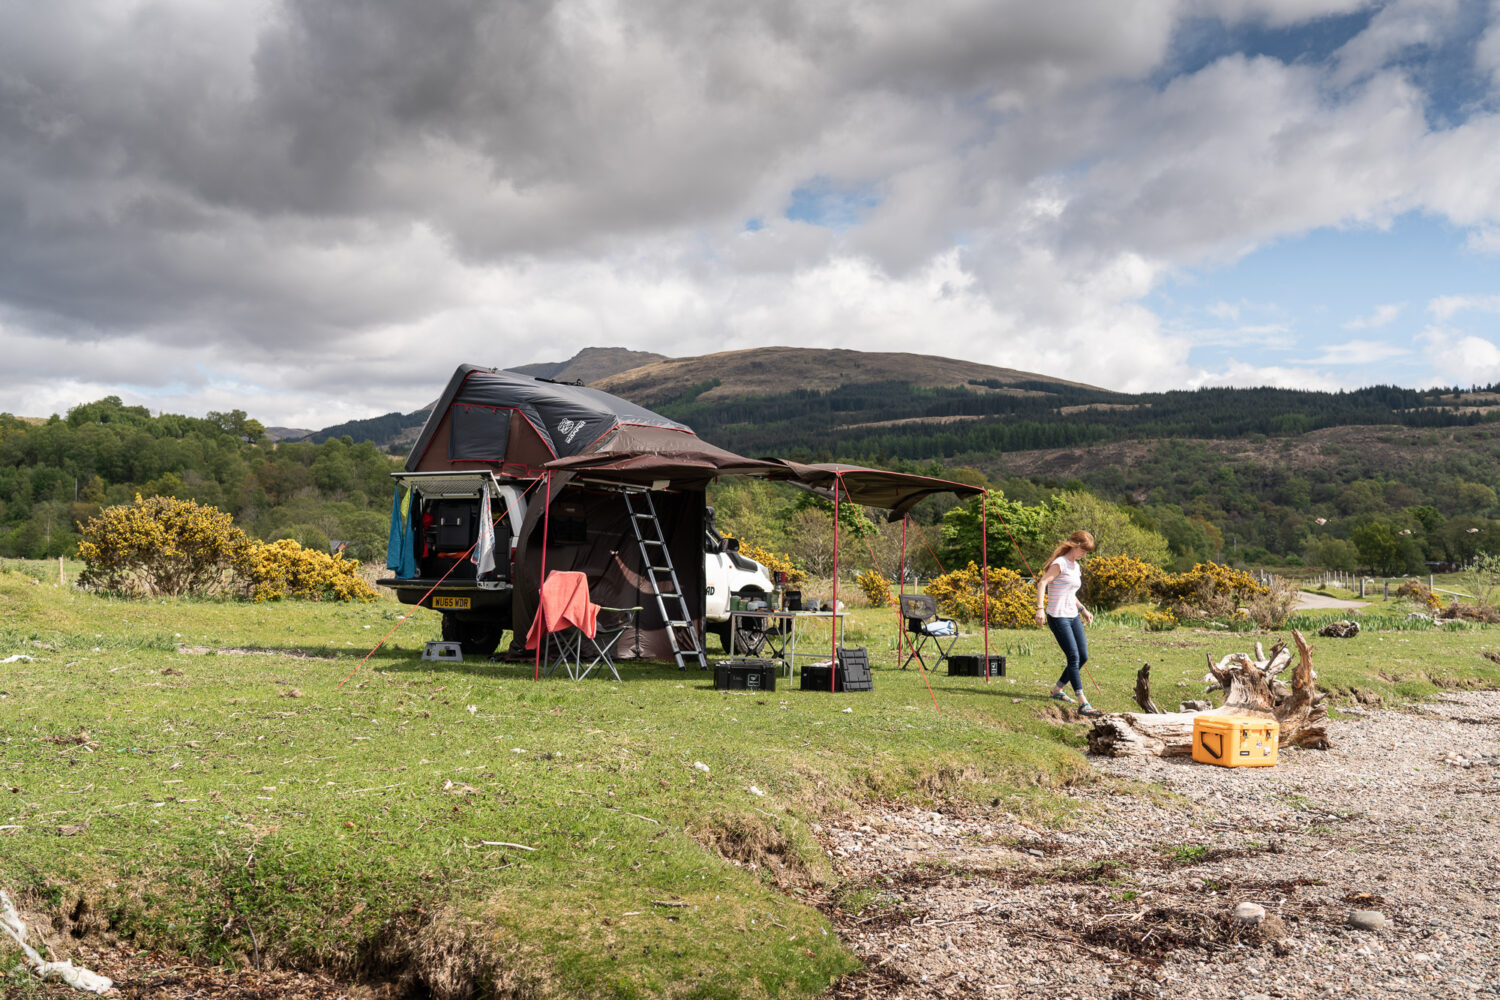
[1089,628,1329,757]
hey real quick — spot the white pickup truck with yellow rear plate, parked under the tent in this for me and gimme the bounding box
[378,471,773,655]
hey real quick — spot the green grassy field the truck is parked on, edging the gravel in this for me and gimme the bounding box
[0,561,1500,997]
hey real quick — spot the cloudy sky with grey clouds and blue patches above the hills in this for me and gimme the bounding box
[0,0,1500,427]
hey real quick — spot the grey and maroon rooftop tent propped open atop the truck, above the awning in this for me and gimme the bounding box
[407,364,705,477]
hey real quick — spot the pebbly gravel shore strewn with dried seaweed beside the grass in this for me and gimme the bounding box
[822,691,1500,999]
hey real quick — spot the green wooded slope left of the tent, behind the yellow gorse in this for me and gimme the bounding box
[0,396,396,558]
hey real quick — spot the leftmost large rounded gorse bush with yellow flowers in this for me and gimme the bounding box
[78,493,249,597]
